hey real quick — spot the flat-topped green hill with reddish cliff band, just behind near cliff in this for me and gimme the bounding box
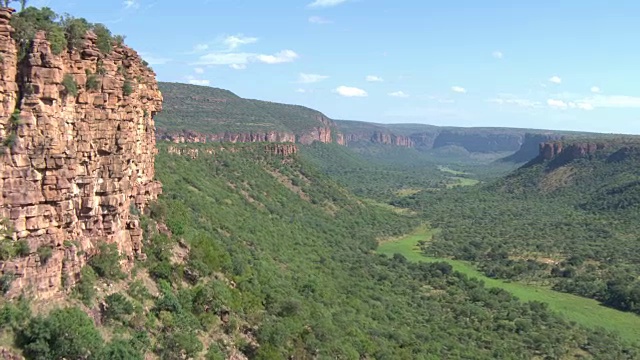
[157,83,344,144]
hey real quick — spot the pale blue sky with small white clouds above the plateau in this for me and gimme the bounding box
[30,0,640,134]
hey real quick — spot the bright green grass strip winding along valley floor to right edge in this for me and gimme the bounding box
[378,226,640,343]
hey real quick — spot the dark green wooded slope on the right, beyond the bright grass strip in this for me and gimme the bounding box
[395,143,640,313]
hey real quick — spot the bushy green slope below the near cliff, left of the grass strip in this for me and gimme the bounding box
[0,145,637,359]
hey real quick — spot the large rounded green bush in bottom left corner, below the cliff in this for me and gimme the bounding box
[18,308,104,359]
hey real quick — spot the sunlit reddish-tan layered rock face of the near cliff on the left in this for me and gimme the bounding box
[0,9,162,299]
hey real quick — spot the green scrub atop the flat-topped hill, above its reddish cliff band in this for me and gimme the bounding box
[156,82,340,134]
